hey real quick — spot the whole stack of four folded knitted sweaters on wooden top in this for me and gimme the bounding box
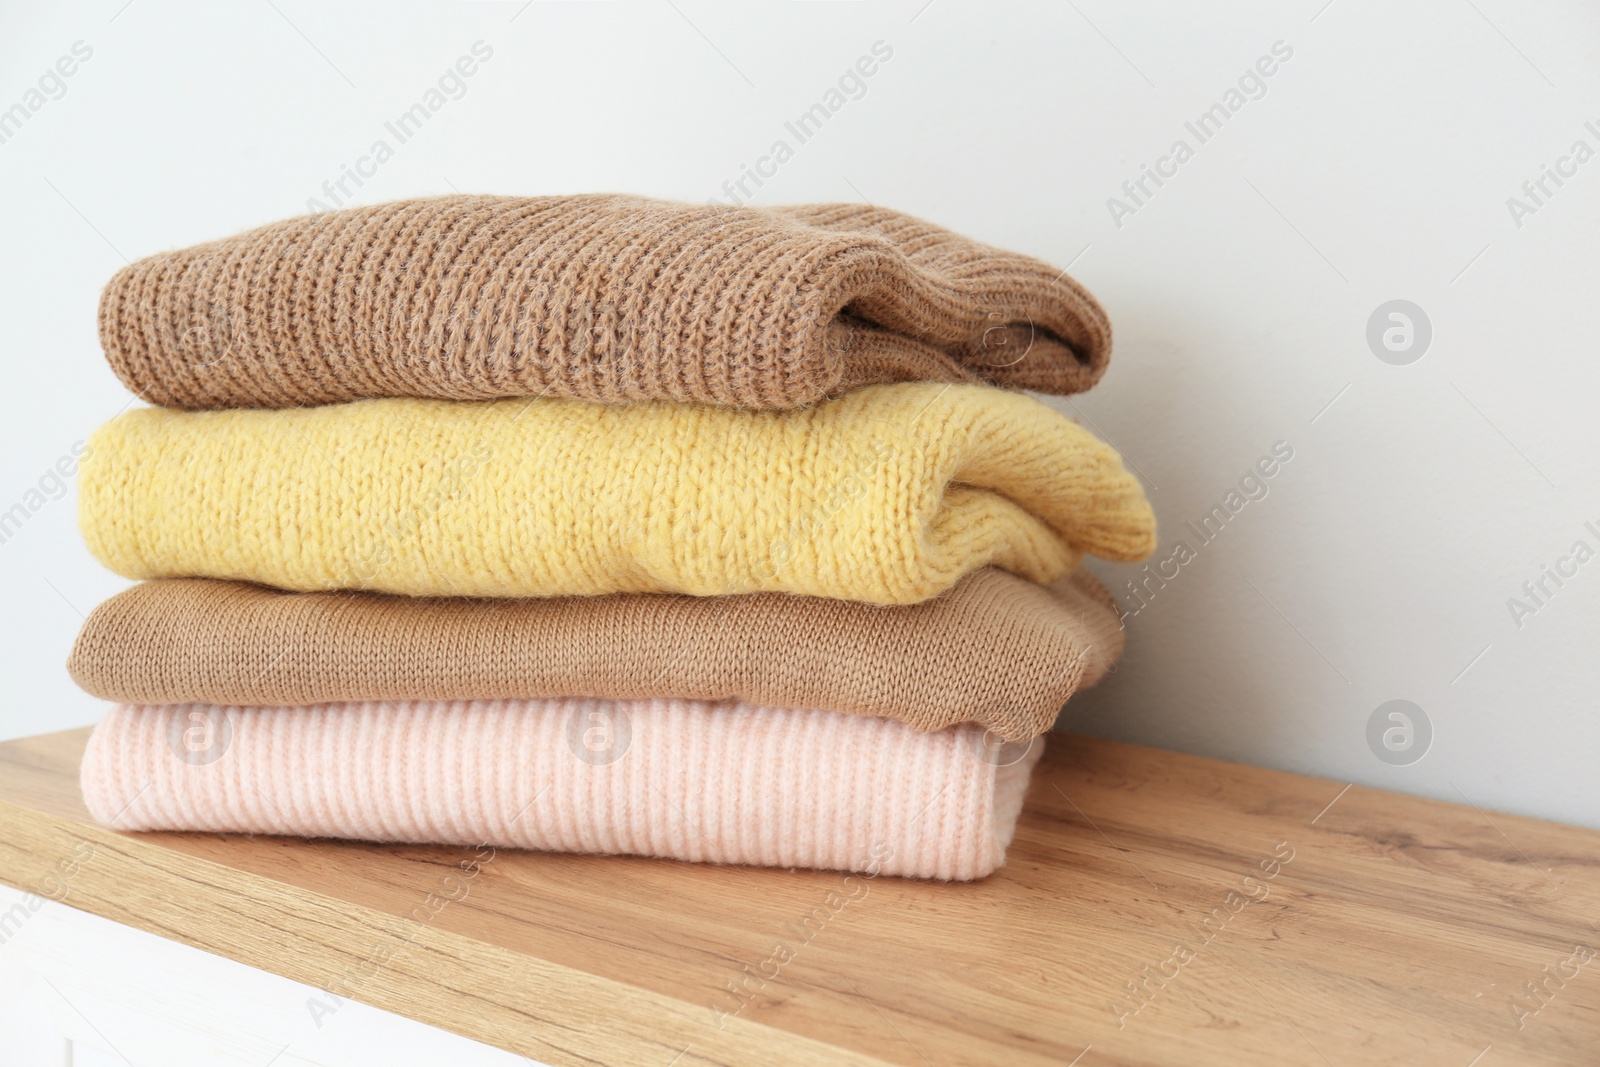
[70,195,1155,880]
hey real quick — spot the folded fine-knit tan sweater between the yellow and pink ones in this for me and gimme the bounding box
[67,569,1123,741]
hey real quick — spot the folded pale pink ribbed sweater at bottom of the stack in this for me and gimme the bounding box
[83,699,1045,880]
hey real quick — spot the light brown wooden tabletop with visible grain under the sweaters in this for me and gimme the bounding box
[0,731,1600,1067]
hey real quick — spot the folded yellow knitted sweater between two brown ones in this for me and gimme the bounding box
[78,382,1155,605]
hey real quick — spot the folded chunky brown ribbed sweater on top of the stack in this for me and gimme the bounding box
[99,195,1110,408]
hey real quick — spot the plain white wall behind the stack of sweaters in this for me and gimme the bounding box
[0,0,1600,825]
